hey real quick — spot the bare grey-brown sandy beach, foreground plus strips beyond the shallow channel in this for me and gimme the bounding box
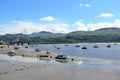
[0,47,120,80]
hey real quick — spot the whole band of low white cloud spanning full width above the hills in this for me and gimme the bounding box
[0,19,120,35]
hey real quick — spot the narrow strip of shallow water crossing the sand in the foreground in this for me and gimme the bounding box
[0,54,120,69]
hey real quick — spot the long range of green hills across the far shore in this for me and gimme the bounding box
[0,27,120,43]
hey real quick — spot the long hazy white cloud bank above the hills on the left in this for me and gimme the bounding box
[0,21,70,35]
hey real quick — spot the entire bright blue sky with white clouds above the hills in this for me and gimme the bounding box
[0,0,120,35]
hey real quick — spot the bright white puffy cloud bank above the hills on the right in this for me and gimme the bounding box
[75,19,120,31]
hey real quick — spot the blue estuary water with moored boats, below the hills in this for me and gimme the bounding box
[30,43,120,60]
